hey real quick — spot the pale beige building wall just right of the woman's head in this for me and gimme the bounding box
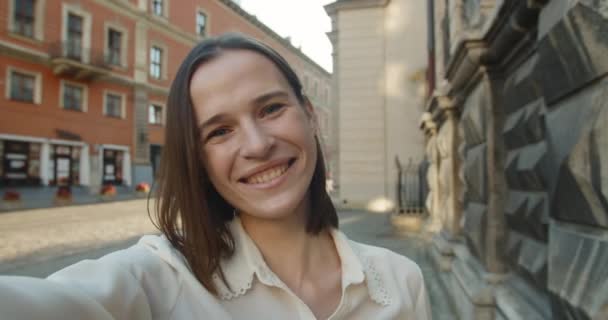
[325,0,426,210]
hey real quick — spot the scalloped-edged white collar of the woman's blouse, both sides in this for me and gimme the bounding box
[213,217,391,306]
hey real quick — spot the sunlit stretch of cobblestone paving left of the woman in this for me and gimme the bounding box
[0,199,158,273]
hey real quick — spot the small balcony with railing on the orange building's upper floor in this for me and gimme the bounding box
[49,41,110,80]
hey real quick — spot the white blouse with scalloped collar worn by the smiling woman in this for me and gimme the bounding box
[0,219,431,320]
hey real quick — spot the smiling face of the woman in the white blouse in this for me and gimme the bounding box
[190,50,317,219]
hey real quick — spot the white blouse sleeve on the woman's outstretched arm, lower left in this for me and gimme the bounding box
[0,249,152,320]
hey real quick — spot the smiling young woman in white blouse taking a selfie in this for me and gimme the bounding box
[0,34,430,320]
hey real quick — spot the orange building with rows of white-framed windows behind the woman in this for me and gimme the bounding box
[0,0,332,192]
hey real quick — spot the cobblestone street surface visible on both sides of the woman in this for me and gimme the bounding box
[0,200,456,320]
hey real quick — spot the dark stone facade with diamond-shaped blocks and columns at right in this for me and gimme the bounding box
[421,0,608,319]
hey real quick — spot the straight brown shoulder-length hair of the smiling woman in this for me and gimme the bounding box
[148,33,338,294]
